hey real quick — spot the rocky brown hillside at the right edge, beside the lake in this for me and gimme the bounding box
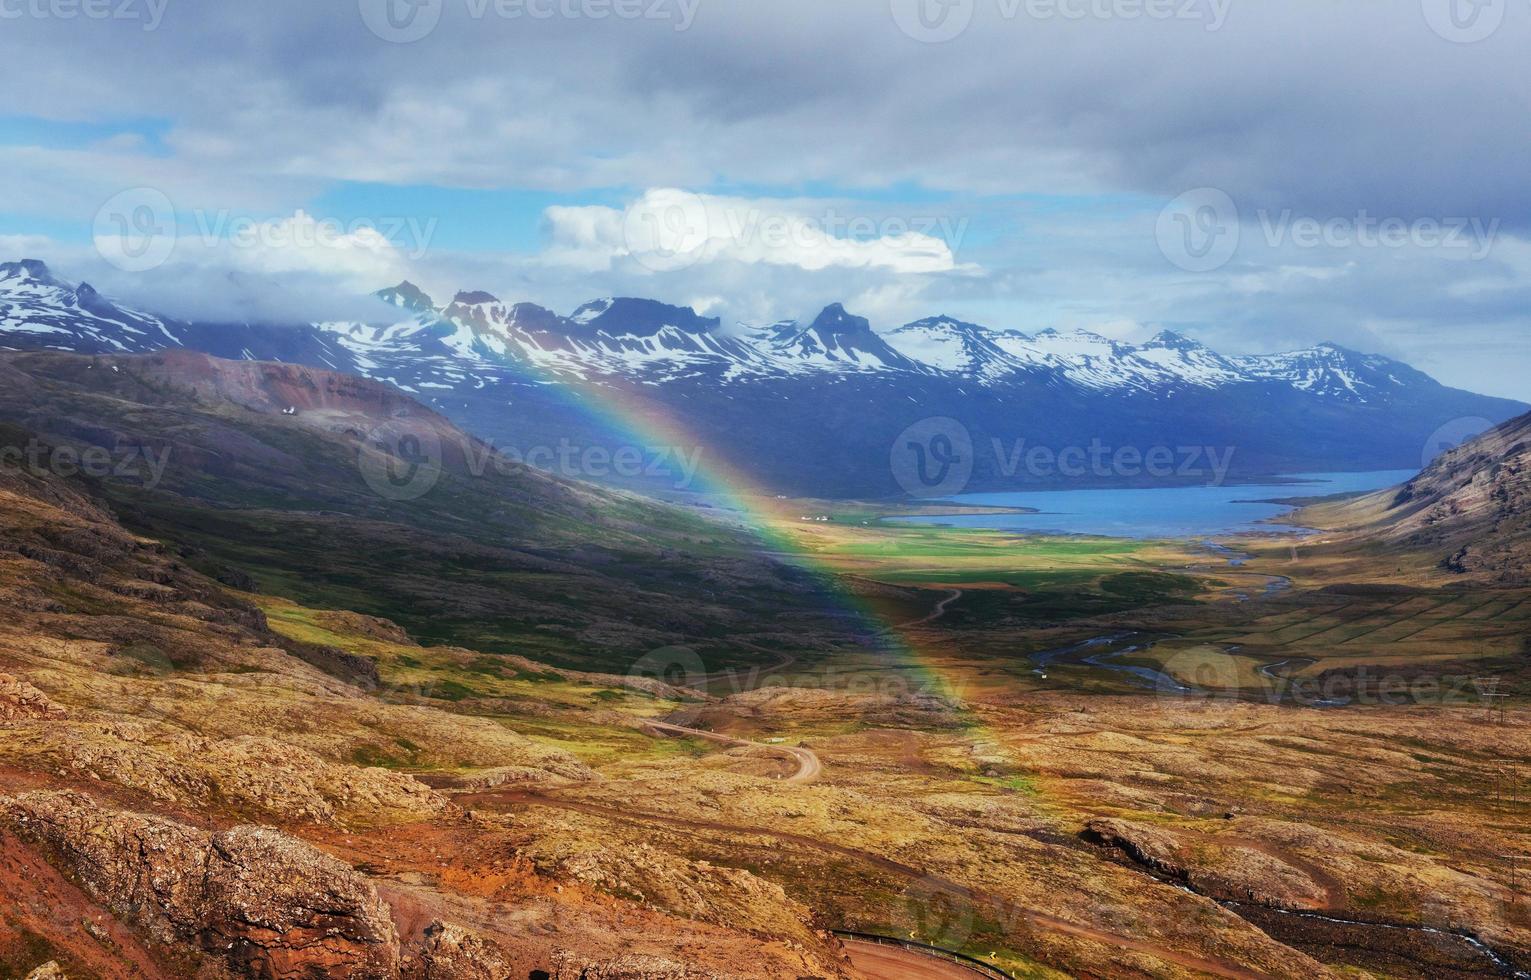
[1307,415,1531,582]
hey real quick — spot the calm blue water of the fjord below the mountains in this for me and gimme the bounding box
[897,470,1415,537]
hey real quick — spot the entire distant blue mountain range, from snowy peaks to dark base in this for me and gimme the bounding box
[0,260,1526,496]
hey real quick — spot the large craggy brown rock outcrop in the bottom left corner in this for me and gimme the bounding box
[0,792,400,980]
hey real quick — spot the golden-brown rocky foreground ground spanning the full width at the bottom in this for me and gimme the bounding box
[0,416,1531,980]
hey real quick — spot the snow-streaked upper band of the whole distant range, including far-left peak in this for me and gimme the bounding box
[0,260,1457,403]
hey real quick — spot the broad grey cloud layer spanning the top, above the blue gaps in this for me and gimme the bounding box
[0,0,1531,225]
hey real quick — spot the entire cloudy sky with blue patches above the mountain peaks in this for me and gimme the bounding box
[0,0,1531,400]
